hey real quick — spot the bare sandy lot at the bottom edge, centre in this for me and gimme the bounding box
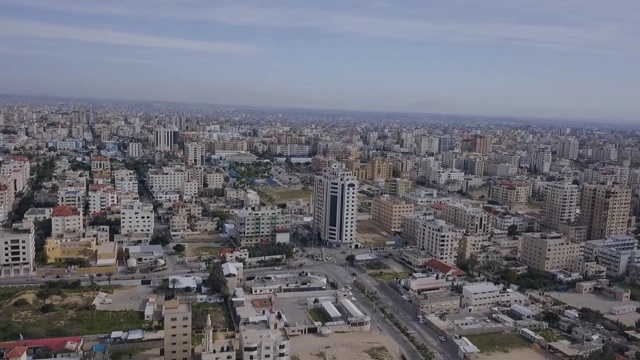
[291,332,400,360]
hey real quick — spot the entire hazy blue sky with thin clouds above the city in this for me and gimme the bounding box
[0,0,640,122]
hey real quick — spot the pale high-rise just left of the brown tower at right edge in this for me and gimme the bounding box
[542,183,579,230]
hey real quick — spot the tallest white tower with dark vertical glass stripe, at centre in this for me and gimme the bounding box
[313,163,358,247]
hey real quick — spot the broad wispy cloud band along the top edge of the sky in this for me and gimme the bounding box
[0,0,638,53]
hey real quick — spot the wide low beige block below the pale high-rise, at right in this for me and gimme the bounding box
[520,233,584,271]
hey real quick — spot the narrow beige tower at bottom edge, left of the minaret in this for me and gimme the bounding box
[163,300,192,360]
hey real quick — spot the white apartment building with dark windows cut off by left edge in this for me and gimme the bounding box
[0,221,36,278]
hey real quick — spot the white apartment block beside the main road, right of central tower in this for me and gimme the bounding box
[418,219,462,264]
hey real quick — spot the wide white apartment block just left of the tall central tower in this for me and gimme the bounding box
[233,206,291,247]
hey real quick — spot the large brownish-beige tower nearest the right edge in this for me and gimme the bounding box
[580,184,631,240]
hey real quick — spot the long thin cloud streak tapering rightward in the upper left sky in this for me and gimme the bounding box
[0,19,260,54]
